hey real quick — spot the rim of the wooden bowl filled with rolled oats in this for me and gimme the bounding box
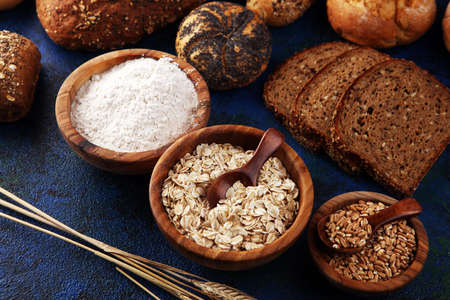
[149,124,314,263]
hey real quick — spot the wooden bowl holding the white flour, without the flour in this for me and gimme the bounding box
[55,49,210,174]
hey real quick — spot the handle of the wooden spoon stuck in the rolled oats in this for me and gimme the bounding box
[241,128,284,185]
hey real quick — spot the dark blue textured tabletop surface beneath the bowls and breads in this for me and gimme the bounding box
[0,0,450,300]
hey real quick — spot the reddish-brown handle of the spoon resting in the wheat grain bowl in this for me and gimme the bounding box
[367,198,422,231]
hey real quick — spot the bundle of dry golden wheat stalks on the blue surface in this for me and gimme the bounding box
[0,187,255,300]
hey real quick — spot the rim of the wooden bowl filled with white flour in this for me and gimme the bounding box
[55,48,211,163]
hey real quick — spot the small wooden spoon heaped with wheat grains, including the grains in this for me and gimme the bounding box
[317,198,422,254]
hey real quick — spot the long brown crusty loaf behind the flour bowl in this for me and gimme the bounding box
[36,0,205,50]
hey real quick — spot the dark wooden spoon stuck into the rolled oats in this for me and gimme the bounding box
[206,128,284,209]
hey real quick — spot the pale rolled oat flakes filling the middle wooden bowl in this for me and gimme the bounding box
[161,144,299,250]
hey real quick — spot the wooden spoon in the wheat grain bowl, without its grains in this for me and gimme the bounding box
[317,198,422,254]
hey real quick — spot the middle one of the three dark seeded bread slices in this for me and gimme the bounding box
[289,47,390,173]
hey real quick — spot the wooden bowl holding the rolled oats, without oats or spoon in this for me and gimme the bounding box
[150,125,314,270]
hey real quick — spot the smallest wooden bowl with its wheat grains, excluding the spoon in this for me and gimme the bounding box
[308,192,428,295]
